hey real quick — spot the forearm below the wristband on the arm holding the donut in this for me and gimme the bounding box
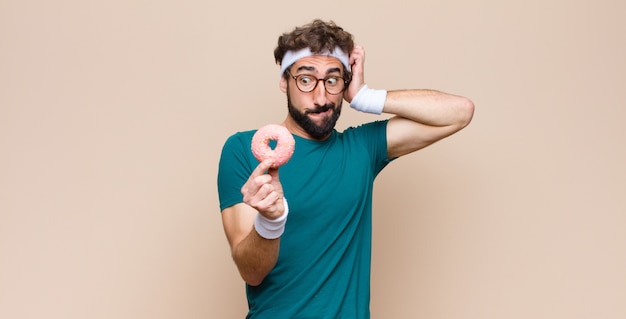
[232,229,280,286]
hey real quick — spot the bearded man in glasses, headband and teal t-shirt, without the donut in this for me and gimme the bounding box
[218,20,474,319]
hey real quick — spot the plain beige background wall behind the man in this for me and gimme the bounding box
[0,0,626,319]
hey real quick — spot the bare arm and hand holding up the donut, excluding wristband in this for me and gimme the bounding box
[222,160,285,286]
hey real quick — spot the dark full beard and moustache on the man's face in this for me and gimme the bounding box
[287,93,343,139]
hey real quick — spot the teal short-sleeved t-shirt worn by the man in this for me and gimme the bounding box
[218,120,390,319]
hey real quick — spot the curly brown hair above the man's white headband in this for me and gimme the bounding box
[274,19,354,74]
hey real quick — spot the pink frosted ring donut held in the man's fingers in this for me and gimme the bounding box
[252,124,296,168]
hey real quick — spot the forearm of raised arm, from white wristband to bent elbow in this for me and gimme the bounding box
[383,90,474,129]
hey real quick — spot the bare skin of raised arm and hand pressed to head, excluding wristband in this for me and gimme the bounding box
[344,46,474,158]
